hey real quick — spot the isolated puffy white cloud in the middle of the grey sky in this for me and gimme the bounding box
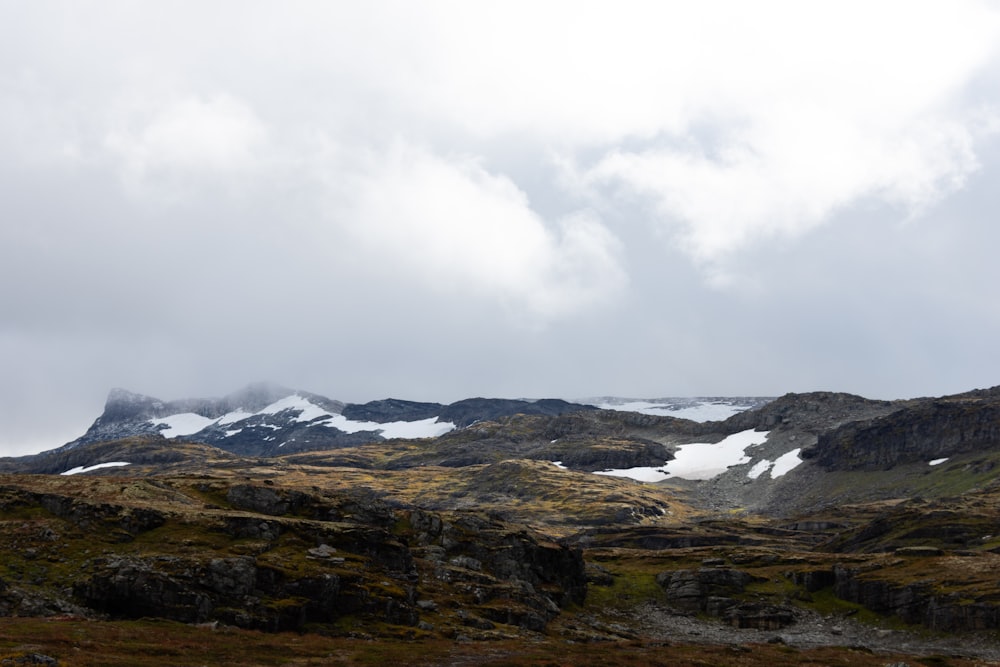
[331,142,626,320]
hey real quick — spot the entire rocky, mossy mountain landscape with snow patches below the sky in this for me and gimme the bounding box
[0,385,1000,665]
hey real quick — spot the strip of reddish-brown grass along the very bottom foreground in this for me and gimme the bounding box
[0,618,998,667]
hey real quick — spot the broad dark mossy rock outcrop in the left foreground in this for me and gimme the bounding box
[0,484,586,631]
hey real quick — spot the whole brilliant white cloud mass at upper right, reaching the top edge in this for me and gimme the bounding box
[354,2,1000,279]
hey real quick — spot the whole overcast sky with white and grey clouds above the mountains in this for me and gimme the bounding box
[0,0,1000,455]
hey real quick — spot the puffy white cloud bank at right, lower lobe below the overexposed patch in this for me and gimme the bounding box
[585,110,977,268]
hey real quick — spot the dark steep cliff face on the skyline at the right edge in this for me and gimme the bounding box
[803,393,1000,470]
